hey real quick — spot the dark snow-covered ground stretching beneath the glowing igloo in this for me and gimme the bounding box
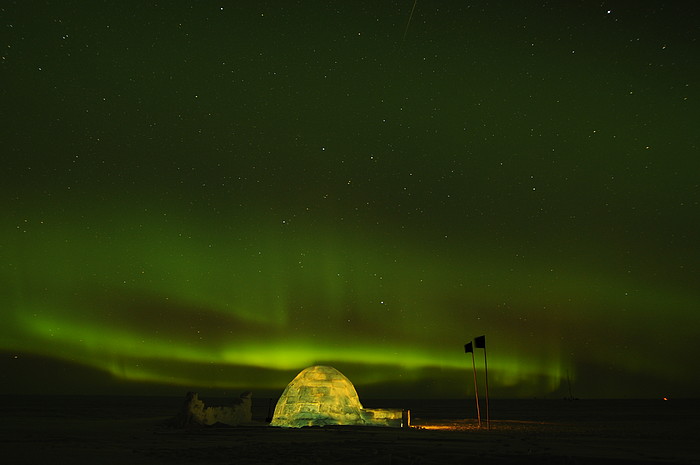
[0,396,700,465]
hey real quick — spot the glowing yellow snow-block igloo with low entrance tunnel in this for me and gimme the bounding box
[270,365,410,428]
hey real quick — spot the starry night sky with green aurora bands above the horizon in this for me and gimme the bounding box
[0,0,700,398]
